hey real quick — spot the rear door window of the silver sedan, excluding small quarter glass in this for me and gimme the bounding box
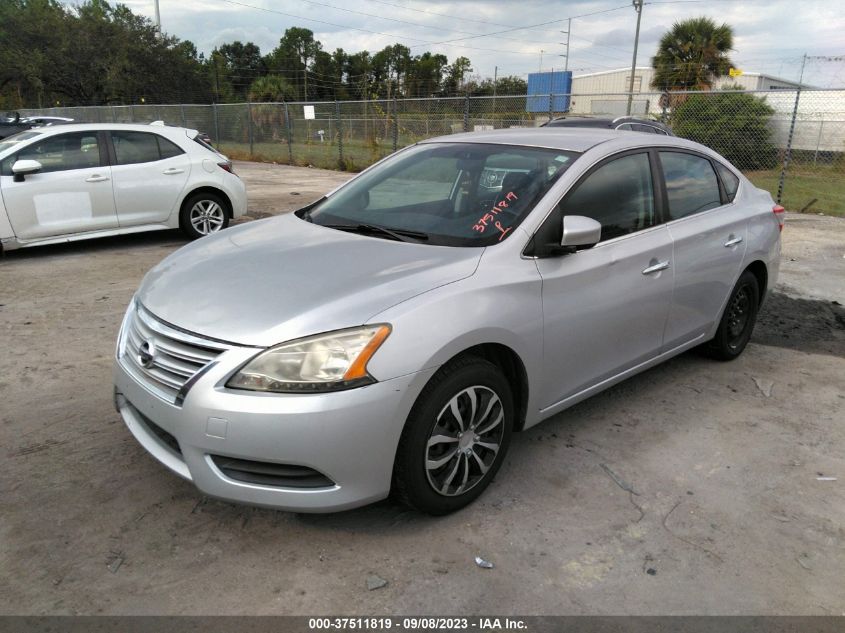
[660,152,722,220]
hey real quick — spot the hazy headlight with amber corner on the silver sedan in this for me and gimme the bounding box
[226,324,390,393]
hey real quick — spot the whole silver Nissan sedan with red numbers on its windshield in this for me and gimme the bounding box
[114,129,784,514]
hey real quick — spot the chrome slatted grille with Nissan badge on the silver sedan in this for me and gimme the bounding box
[121,305,231,404]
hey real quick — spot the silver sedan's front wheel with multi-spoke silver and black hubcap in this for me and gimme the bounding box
[393,357,514,515]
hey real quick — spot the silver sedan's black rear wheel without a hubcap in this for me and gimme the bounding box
[706,270,760,361]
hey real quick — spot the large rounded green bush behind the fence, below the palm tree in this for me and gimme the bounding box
[671,87,777,171]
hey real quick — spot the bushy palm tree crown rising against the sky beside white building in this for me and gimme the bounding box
[651,17,733,92]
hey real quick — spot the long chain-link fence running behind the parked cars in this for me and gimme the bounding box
[22,90,845,215]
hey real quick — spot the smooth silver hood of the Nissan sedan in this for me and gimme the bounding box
[137,214,484,347]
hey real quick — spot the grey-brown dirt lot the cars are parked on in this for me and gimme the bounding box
[0,164,845,615]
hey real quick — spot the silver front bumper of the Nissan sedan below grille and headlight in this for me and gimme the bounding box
[114,352,435,512]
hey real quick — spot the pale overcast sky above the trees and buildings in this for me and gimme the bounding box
[71,0,845,87]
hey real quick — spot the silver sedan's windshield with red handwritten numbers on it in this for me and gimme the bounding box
[298,143,578,246]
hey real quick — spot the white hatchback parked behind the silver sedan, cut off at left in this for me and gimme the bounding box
[0,119,247,250]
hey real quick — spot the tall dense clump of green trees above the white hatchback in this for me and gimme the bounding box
[0,0,209,107]
